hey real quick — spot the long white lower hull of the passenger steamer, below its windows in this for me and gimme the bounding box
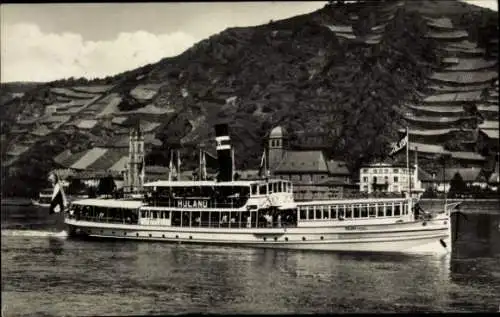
[66,215,451,253]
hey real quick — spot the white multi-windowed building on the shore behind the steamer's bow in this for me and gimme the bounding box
[359,163,423,193]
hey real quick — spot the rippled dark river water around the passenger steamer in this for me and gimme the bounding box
[1,201,500,316]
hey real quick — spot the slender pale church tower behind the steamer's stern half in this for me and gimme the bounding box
[125,124,146,192]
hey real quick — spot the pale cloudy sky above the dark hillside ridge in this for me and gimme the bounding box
[0,0,498,82]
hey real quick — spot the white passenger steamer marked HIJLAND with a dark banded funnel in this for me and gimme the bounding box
[65,125,451,253]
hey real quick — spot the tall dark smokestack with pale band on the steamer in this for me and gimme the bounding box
[215,123,233,182]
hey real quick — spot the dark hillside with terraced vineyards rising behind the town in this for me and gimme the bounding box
[0,0,498,196]
